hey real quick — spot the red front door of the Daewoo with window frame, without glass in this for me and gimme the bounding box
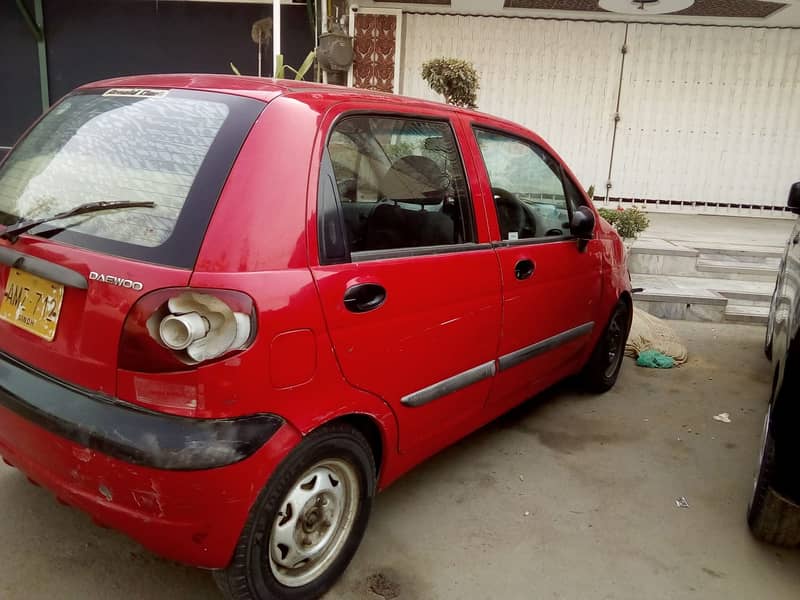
[454,117,604,408]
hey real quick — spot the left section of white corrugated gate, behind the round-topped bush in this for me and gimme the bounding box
[400,15,625,189]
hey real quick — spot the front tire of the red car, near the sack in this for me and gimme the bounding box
[581,300,632,394]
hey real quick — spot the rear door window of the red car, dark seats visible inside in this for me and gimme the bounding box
[328,115,475,252]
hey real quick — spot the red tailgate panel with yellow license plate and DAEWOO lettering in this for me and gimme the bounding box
[0,239,191,395]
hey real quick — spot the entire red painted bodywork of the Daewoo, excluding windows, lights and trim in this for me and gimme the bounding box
[0,75,630,568]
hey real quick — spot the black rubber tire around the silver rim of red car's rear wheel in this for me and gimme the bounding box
[214,424,376,600]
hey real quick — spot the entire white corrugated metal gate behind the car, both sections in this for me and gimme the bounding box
[401,14,800,211]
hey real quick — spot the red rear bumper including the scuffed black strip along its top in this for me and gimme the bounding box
[0,354,300,568]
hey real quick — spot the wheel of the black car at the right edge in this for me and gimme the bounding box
[747,403,800,546]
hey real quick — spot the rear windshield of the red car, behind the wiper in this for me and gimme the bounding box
[0,88,264,268]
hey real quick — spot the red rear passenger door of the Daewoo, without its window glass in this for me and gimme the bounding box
[308,101,501,453]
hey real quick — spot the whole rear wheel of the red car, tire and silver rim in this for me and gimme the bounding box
[214,424,375,600]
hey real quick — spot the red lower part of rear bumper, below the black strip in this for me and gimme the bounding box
[0,408,301,569]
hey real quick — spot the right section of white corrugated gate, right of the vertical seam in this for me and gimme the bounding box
[612,25,800,206]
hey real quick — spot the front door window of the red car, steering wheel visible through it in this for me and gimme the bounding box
[475,129,570,241]
